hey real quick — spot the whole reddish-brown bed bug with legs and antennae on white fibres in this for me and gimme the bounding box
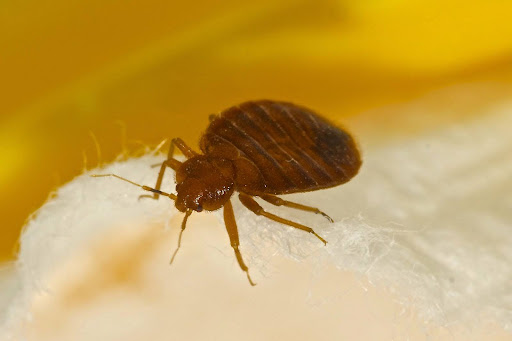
[95,100,361,285]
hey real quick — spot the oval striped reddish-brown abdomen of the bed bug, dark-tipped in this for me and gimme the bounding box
[201,101,361,194]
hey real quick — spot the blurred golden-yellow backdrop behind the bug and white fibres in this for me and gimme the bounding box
[0,0,512,259]
